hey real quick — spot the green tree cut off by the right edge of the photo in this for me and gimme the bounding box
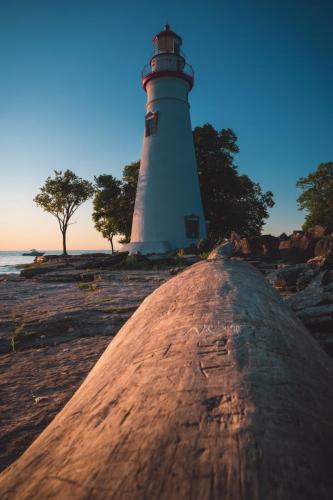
[296,162,333,231]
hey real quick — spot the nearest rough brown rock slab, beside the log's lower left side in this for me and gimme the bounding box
[0,336,111,471]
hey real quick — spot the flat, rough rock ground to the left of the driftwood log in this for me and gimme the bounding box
[0,271,170,471]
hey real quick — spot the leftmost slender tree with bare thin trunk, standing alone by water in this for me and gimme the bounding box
[34,170,94,255]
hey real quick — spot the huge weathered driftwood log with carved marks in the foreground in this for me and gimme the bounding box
[0,260,333,500]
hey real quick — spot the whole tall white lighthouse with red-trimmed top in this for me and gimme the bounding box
[127,24,206,254]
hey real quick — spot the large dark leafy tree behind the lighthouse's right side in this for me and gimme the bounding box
[193,123,274,239]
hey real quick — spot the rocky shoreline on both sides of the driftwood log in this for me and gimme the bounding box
[0,228,333,470]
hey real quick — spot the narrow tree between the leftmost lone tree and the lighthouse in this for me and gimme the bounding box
[92,174,123,253]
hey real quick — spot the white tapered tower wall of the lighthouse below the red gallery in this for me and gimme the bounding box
[130,77,206,253]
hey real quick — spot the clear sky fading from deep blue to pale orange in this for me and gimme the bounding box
[0,0,333,250]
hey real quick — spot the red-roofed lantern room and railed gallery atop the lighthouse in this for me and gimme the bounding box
[142,24,194,90]
